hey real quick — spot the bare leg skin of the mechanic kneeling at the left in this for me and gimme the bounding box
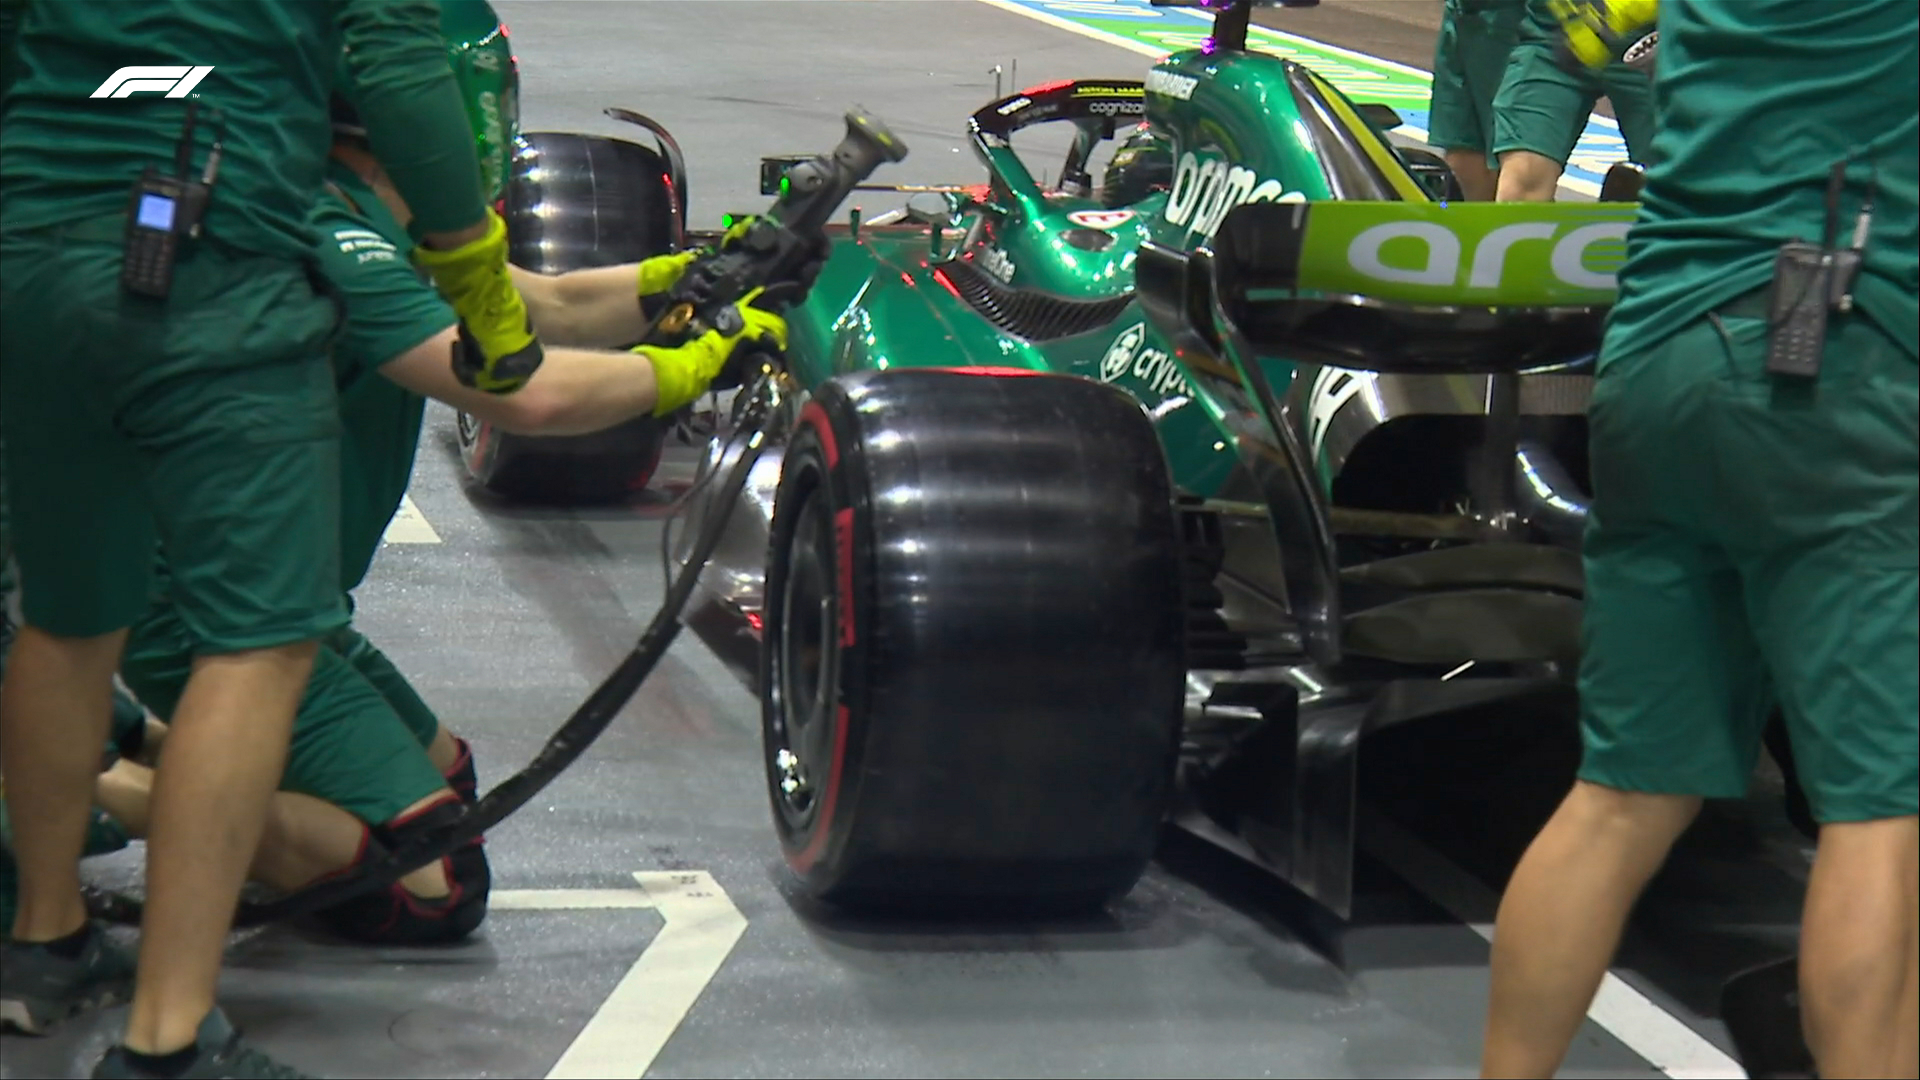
[94,761,453,899]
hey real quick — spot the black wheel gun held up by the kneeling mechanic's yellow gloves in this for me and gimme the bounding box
[645,111,906,346]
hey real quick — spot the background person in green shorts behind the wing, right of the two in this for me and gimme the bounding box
[1492,0,1653,202]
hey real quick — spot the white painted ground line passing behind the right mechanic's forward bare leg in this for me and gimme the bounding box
[1361,811,1747,1080]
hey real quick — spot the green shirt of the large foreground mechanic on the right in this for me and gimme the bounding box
[1601,0,1920,363]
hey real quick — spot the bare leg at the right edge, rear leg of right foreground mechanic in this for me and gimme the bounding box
[1799,817,1920,1076]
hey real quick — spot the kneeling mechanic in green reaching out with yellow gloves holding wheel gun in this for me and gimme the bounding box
[98,0,785,957]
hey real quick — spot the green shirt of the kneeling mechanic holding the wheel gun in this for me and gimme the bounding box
[313,163,457,592]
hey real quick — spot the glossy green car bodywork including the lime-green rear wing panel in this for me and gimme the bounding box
[771,39,1636,496]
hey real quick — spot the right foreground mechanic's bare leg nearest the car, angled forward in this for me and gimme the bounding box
[1480,780,1699,1076]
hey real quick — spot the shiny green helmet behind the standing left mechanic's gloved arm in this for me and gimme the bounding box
[332,0,520,202]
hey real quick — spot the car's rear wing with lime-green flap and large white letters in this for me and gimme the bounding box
[1137,202,1638,375]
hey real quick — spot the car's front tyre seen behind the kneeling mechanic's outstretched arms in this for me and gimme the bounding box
[459,131,684,503]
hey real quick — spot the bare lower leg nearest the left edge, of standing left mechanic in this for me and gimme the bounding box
[0,626,127,942]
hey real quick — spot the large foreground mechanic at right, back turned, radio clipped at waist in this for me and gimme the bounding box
[1482,0,1920,1076]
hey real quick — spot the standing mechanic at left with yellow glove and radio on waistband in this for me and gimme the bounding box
[0,0,540,1076]
